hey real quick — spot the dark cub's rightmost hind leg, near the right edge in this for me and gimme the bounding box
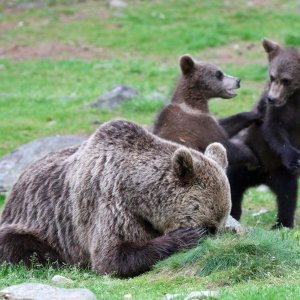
[268,169,298,229]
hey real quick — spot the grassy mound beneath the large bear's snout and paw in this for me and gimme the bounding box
[155,228,300,285]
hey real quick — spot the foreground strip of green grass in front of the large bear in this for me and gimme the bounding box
[0,229,300,299]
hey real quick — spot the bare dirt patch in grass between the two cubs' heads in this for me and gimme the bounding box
[195,42,266,66]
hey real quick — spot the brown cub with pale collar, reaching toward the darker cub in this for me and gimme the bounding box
[153,55,260,165]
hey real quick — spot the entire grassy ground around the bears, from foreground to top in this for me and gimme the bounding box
[0,0,300,299]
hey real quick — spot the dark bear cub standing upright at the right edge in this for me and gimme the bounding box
[228,39,300,228]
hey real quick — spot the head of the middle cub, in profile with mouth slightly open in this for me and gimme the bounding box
[179,55,240,99]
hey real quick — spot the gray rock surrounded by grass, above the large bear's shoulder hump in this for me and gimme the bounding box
[87,85,139,109]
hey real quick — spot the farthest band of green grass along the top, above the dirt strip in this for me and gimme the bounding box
[1,0,300,56]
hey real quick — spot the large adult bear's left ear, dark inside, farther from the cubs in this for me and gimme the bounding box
[172,147,195,184]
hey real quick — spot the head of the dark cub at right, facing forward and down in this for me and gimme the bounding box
[262,38,300,107]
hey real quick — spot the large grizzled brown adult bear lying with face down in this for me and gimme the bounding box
[0,121,231,277]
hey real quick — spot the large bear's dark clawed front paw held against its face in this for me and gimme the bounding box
[166,227,209,250]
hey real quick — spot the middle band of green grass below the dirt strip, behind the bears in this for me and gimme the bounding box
[0,59,266,155]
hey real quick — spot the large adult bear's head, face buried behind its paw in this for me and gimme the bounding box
[163,143,231,232]
